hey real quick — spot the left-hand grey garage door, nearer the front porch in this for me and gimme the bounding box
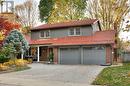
[60,48,80,64]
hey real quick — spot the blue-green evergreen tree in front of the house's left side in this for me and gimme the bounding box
[3,30,29,58]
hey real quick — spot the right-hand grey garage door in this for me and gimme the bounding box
[83,48,106,65]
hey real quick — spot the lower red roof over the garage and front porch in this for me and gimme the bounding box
[25,30,115,46]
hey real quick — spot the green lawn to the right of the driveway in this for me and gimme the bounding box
[93,63,130,86]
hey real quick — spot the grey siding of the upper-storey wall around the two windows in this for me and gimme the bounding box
[31,26,93,39]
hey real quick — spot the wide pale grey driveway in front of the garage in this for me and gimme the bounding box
[0,63,104,86]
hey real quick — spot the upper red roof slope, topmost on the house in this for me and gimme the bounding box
[31,19,101,31]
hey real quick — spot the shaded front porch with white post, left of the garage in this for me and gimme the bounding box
[24,46,58,62]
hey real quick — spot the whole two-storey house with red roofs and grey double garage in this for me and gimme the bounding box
[27,19,115,65]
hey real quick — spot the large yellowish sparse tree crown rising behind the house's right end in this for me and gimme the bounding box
[87,0,130,32]
